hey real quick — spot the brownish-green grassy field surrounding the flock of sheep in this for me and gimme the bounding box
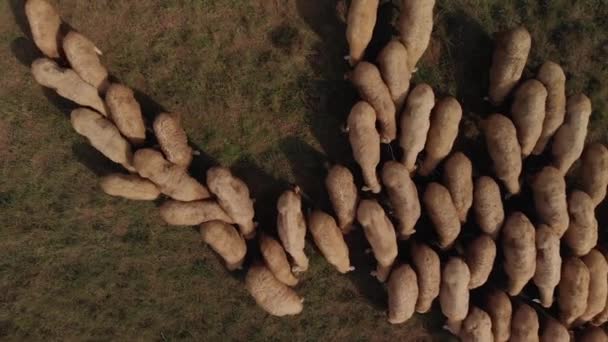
[0,0,608,341]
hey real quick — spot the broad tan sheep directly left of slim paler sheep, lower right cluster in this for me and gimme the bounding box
[502,212,536,296]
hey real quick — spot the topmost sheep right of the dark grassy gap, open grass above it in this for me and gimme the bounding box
[489,27,532,105]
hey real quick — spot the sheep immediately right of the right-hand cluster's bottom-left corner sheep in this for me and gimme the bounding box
[410,243,441,313]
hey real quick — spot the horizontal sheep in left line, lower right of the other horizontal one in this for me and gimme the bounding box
[159,200,234,226]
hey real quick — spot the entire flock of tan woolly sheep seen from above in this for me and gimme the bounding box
[25,0,608,341]
